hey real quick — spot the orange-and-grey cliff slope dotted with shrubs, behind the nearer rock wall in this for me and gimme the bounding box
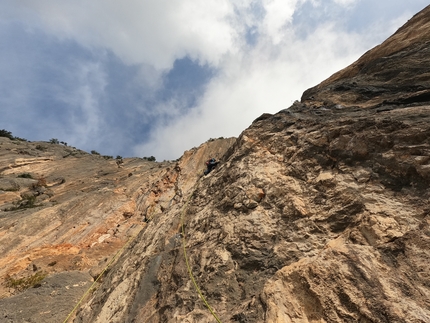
[0,137,235,323]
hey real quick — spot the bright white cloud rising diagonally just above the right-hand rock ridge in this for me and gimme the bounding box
[135,20,372,159]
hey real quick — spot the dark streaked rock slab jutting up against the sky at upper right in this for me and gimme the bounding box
[302,4,430,107]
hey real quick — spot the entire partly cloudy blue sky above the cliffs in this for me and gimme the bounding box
[0,0,428,161]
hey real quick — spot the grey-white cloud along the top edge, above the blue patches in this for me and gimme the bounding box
[13,0,240,71]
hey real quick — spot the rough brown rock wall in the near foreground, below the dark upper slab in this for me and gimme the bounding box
[76,104,430,322]
